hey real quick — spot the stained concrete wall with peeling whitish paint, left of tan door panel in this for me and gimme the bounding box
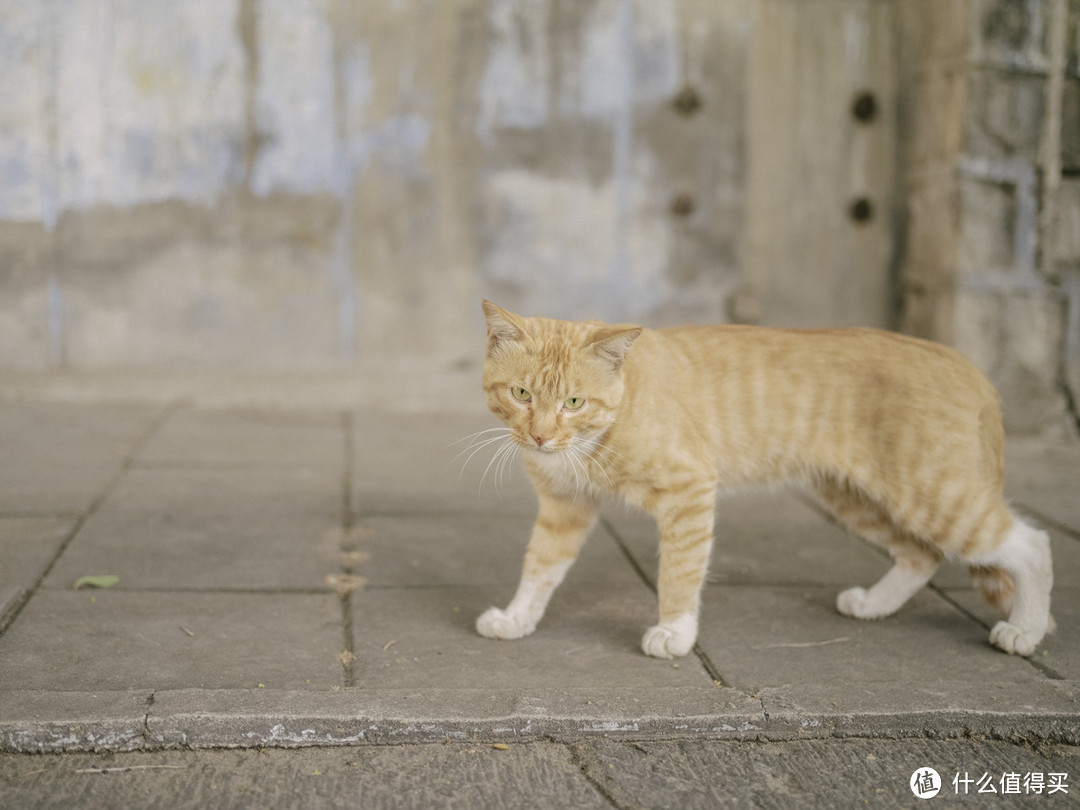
[0,0,748,368]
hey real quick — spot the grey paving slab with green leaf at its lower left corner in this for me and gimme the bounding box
[46,467,343,590]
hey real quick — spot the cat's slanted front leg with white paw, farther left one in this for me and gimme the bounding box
[476,496,596,638]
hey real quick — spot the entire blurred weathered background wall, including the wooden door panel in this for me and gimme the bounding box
[0,0,1080,429]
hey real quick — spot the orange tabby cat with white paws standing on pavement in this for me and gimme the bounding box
[476,301,1053,658]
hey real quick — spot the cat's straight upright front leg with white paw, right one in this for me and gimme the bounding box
[642,486,716,658]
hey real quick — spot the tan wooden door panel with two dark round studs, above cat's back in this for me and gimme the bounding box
[747,0,899,327]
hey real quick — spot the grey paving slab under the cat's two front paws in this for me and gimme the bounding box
[353,586,711,693]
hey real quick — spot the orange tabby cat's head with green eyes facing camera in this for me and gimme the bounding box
[484,301,642,453]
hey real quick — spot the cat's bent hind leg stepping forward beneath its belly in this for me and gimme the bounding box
[814,482,943,619]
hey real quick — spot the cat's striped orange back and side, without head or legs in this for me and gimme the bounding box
[626,325,1003,486]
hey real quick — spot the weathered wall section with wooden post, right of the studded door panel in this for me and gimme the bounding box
[899,0,1080,431]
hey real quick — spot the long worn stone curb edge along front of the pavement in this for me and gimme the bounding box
[0,681,1080,753]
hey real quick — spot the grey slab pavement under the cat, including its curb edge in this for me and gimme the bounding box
[0,401,1080,760]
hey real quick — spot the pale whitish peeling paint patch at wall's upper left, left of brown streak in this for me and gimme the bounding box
[58,0,243,210]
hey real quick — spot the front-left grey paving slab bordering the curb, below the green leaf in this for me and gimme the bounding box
[0,590,343,692]
